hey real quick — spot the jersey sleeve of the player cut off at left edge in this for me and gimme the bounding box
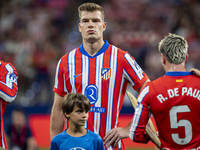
[0,61,18,103]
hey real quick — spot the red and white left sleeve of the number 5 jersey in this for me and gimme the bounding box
[129,86,150,143]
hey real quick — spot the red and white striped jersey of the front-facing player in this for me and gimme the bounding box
[54,41,148,149]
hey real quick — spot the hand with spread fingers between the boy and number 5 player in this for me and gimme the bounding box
[103,128,129,147]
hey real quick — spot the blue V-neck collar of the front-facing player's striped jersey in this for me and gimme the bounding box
[79,40,109,58]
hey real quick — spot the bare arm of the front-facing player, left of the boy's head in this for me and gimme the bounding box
[50,93,65,140]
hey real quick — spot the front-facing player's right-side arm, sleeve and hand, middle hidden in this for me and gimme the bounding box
[104,53,150,147]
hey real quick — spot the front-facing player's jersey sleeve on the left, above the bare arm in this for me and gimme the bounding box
[53,58,68,96]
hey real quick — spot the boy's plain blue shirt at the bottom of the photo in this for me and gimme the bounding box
[50,130,105,150]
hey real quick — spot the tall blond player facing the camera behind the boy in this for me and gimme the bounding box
[50,3,148,150]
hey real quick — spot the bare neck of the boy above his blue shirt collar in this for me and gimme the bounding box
[66,126,87,137]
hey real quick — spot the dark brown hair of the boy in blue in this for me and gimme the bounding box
[62,93,91,119]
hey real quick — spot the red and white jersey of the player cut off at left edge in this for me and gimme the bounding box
[0,60,18,149]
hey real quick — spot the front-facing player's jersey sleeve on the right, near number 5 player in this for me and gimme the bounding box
[123,52,149,90]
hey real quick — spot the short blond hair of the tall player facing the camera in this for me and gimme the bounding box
[78,3,105,21]
